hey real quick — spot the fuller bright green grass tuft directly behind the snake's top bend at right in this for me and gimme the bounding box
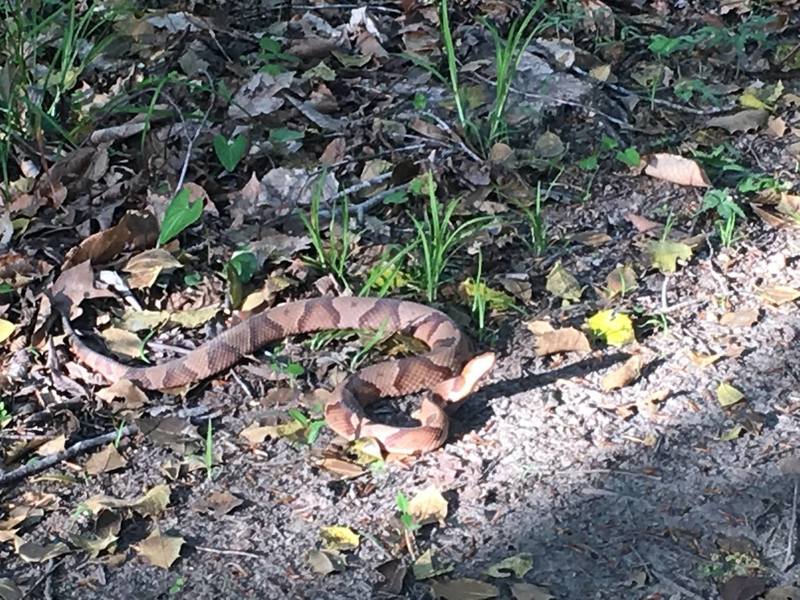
[411,171,492,302]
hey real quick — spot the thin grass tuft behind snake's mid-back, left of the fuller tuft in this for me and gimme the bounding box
[300,173,351,286]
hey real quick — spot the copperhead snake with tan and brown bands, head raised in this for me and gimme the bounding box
[62,297,495,454]
